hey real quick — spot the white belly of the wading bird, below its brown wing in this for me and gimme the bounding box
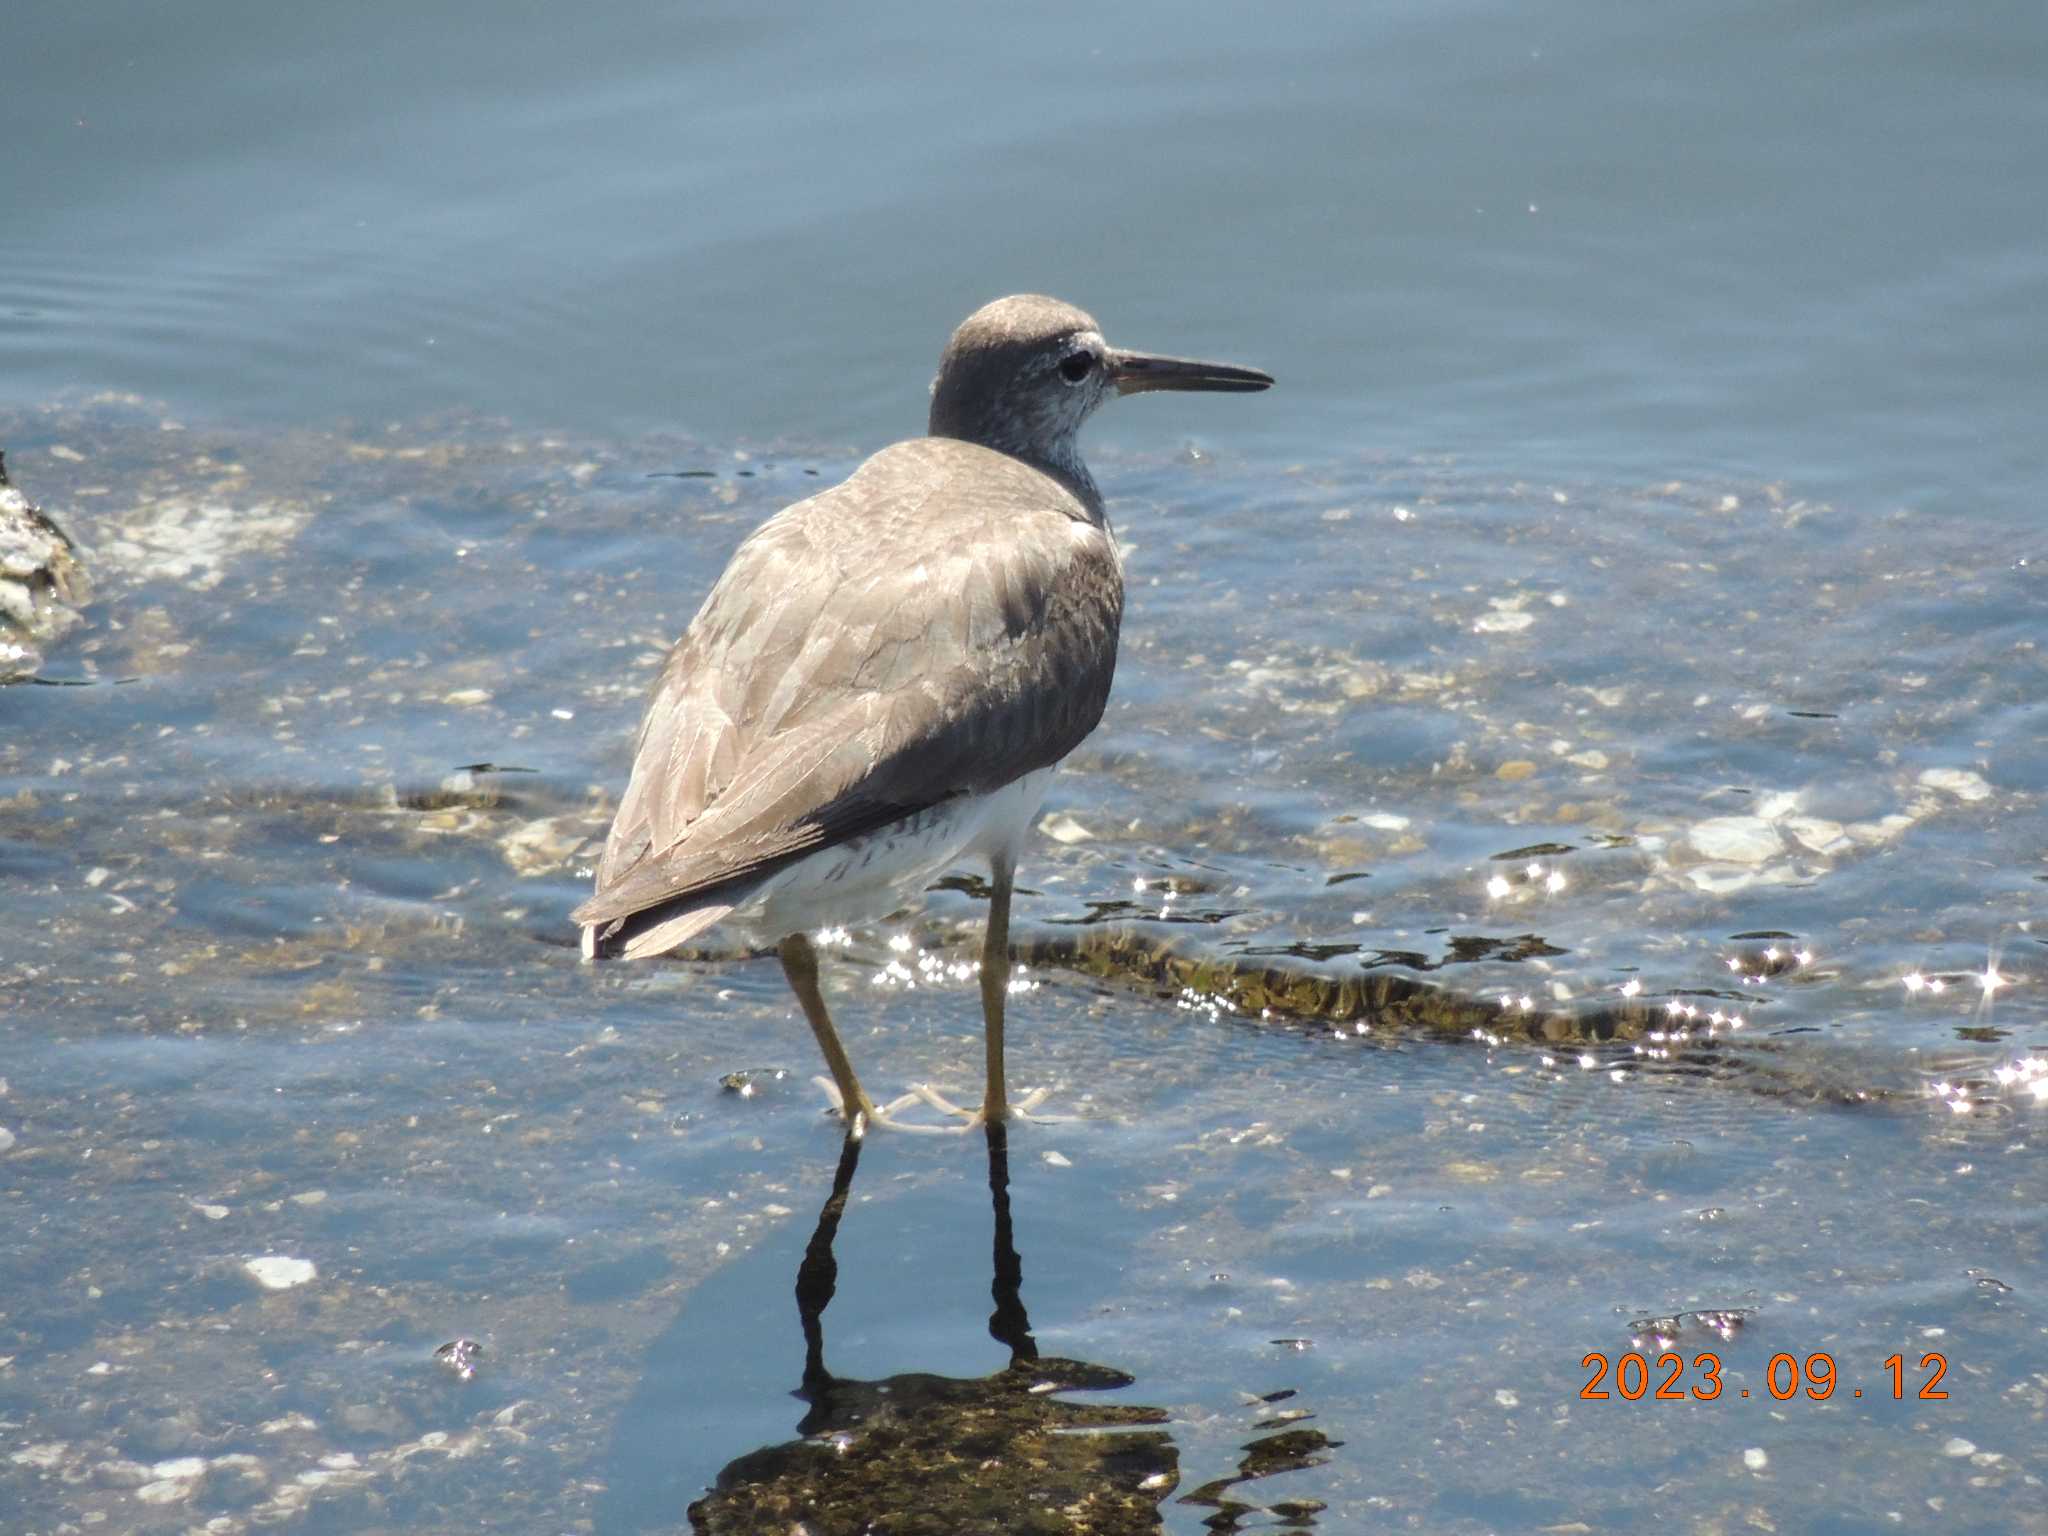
[723,768,1053,942]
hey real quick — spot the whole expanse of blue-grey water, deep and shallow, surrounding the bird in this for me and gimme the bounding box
[0,4,2048,1532]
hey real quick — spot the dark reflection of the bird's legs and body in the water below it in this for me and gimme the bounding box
[690,1124,1180,1536]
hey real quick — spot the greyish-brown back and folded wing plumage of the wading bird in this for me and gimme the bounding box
[573,438,1122,926]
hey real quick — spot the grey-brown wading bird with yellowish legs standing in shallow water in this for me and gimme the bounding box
[573,293,1272,1135]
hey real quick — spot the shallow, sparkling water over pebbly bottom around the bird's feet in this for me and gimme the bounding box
[0,406,2048,1530]
